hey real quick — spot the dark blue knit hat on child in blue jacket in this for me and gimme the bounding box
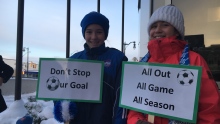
[80,11,109,39]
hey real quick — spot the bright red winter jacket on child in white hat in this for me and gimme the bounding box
[127,37,220,124]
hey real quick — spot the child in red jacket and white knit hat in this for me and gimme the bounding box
[127,5,220,124]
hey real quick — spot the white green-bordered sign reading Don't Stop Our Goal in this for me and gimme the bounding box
[37,58,104,102]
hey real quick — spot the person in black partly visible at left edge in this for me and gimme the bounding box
[0,55,14,113]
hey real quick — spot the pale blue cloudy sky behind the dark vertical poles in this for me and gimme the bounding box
[0,0,139,63]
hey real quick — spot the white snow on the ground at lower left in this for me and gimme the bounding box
[0,92,63,124]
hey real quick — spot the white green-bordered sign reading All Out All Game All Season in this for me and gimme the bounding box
[120,62,202,122]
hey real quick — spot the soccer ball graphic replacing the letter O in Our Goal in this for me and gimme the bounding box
[47,76,60,91]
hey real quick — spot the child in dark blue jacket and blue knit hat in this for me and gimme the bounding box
[55,12,128,124]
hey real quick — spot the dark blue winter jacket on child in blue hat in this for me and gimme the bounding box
[70,44,128,124]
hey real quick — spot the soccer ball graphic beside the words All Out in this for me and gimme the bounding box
[177,70,194,86]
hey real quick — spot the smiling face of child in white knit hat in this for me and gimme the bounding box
[150,21,179,40]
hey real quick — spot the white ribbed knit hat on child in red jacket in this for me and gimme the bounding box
[148,5,185,39]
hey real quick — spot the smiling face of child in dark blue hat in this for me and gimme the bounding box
[85,24,105,48]
